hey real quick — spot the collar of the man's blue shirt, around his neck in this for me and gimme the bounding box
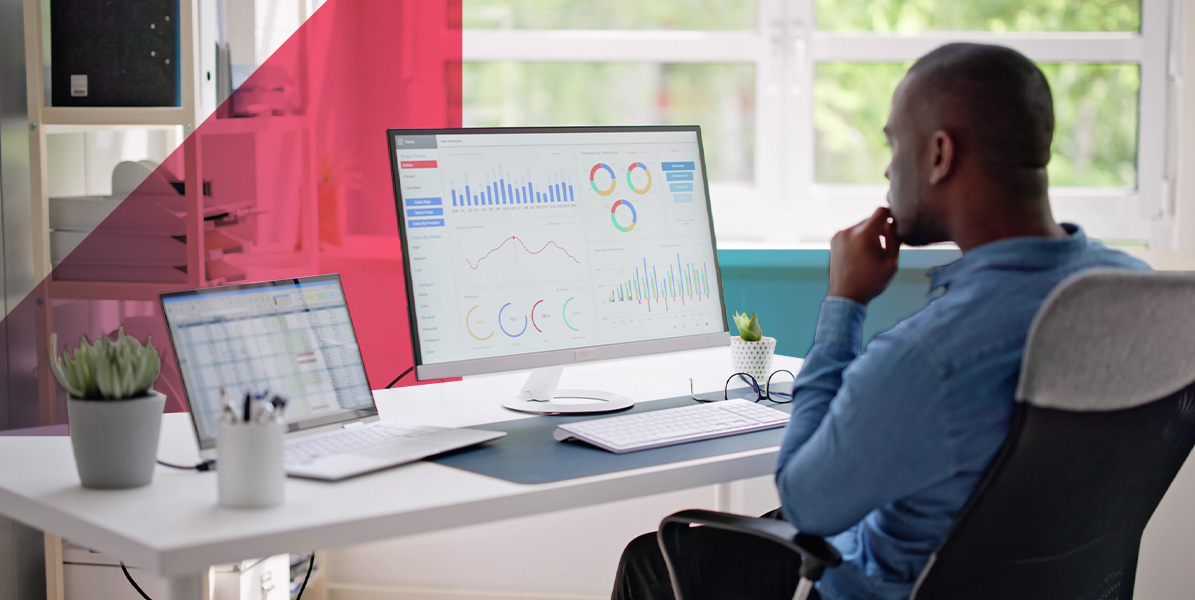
[930,224,1087,290]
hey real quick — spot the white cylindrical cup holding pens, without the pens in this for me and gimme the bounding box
[216,422,287,508]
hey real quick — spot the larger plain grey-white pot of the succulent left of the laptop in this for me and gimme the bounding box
[67,390,166,490]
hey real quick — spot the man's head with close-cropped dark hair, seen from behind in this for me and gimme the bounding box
[884,44,1054,246]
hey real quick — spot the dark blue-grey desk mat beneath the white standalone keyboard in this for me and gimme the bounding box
[427,390,792,484]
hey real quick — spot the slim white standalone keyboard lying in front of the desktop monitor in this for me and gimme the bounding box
[553,398,789,454]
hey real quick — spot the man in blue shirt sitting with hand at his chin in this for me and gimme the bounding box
[613,44,1147,600]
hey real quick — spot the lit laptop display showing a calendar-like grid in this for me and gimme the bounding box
[161,275,376,449]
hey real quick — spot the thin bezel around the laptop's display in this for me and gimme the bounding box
[158,273,378,451]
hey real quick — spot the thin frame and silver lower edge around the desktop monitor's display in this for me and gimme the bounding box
[386,125,730,381]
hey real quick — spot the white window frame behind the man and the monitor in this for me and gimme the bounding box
[462,0,1181,249]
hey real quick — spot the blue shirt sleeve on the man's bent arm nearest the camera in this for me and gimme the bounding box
[776,298,954,535]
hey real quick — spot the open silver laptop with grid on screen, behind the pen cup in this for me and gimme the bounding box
[159,275,505,480]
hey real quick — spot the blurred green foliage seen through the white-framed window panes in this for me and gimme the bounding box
[464,0,1141,188]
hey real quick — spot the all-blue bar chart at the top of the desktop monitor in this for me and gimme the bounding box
[448,165,576,207]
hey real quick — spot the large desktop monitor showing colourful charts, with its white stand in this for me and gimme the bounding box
[387,125,730,414]
